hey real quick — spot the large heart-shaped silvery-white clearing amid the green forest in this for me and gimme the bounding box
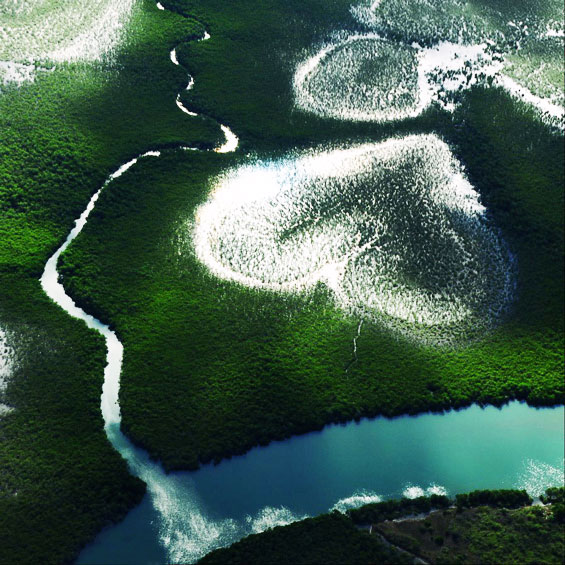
[193,135,514,344]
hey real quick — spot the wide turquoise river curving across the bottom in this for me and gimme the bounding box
[78,402,564,563]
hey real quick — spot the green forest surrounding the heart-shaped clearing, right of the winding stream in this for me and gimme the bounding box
[57,0,564,469]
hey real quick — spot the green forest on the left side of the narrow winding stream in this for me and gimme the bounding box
[0,1,221,563]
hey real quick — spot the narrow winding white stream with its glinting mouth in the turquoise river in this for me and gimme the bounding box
[35,2,240,562]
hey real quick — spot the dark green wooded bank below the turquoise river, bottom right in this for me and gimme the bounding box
[200,488,565,565]
